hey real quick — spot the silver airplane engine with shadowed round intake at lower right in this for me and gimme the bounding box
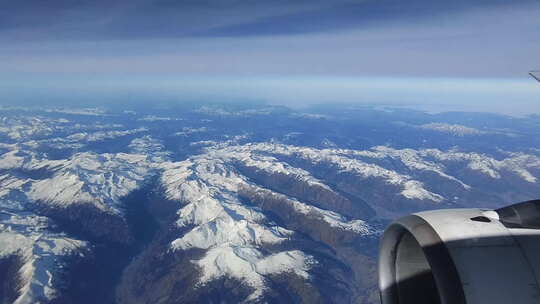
[379,200,540,304]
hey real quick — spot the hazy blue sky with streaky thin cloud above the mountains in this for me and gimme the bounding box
[0,0,540,115]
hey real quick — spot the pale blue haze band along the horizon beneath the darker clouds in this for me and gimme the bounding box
[1,76,540,116]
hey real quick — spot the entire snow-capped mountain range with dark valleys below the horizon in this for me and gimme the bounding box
[0,106,540,303]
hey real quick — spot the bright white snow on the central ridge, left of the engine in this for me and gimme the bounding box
[162,155,311,299]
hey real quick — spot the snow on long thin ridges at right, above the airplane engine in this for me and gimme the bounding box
[246,143,540,191]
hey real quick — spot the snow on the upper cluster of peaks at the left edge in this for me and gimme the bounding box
[0,136,168,214]
